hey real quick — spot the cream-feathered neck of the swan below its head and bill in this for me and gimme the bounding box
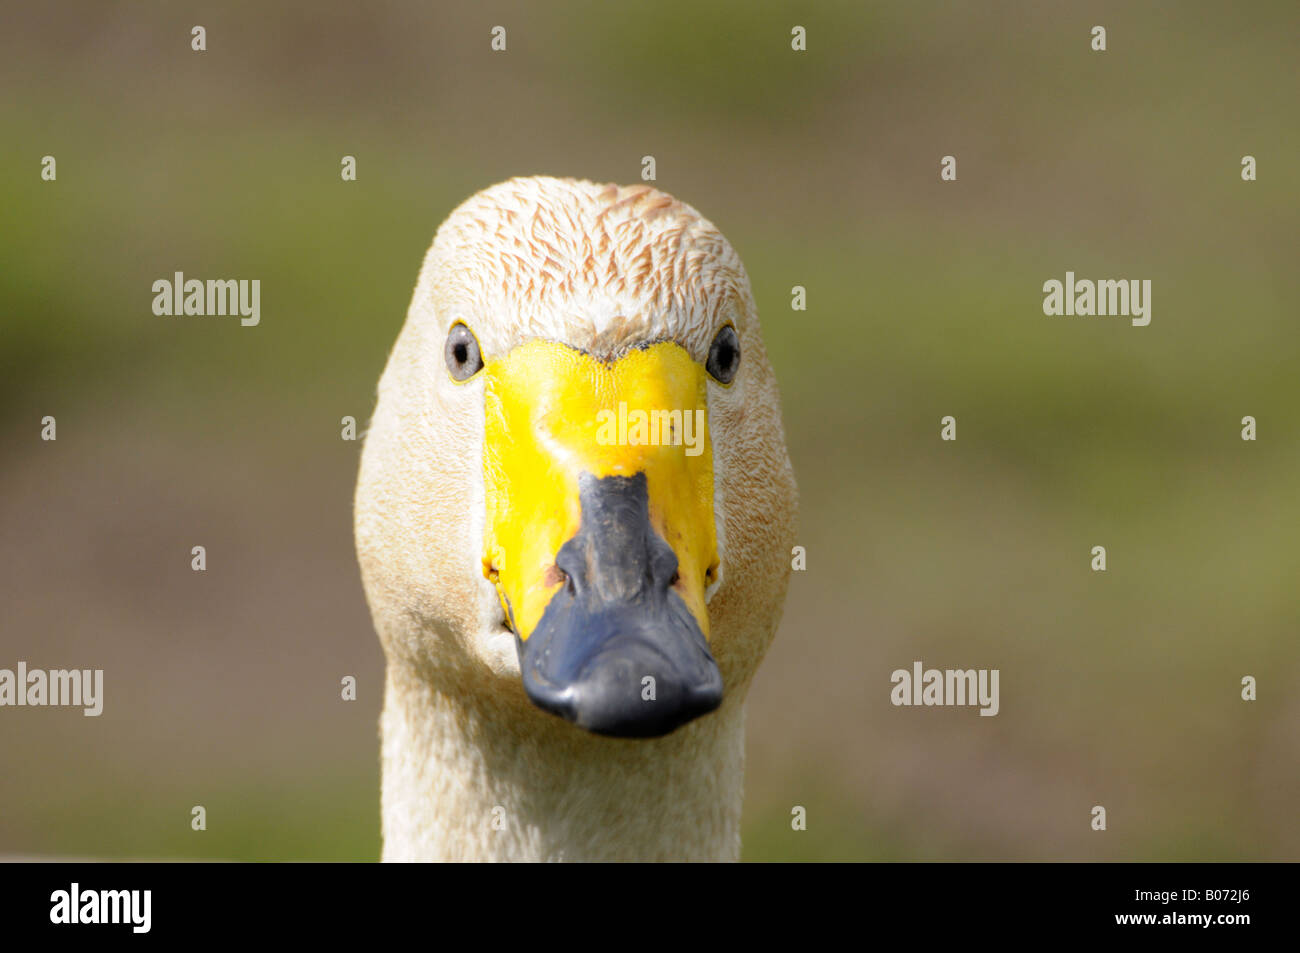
[382,663,744,861]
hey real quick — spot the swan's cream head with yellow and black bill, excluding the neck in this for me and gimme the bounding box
[356,177,796,737]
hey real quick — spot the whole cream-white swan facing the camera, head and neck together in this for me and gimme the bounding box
[354,177,797,861]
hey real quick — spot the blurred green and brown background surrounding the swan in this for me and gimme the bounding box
[0,0,1300,861]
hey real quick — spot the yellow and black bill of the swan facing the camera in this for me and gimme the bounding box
[484,341,723,737]
